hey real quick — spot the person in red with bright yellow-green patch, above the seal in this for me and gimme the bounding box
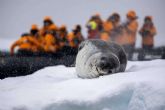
[86,21,100,39]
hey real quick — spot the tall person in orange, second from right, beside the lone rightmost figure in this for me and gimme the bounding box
[120,10,138,60]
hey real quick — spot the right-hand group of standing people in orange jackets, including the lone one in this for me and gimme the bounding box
[86,10,156,59]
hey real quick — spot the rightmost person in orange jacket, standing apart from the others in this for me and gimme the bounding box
[139,16,157,60]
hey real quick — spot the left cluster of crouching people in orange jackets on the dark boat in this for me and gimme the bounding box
[10,16,84,55]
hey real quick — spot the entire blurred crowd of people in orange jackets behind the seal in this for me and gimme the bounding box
[10,10,156,59]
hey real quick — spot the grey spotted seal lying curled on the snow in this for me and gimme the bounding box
[76,39,127,78]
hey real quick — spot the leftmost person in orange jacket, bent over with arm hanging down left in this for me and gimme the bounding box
[10,33,42,55]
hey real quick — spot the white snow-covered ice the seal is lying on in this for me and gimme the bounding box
[0,60,165,110]
